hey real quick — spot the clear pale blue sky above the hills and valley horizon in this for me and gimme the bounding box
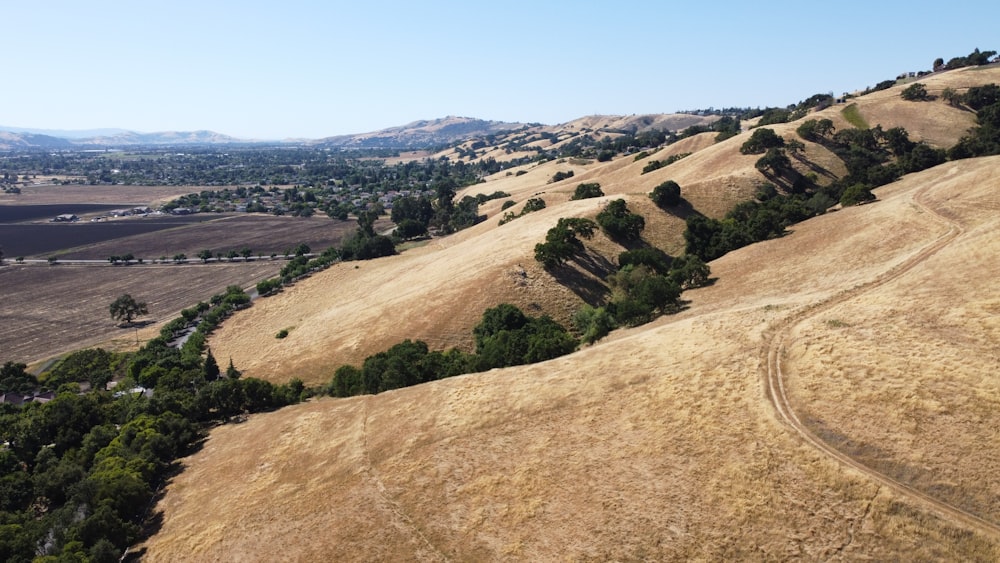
[0,0,1000,139]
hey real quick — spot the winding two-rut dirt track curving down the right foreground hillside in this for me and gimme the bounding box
[761,187,1000,537]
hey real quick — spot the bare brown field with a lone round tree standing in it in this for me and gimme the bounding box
[0,260,284,364]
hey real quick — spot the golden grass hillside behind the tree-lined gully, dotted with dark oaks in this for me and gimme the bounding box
[210,67,1000,384]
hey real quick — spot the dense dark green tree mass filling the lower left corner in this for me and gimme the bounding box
[0,316,307,562]
